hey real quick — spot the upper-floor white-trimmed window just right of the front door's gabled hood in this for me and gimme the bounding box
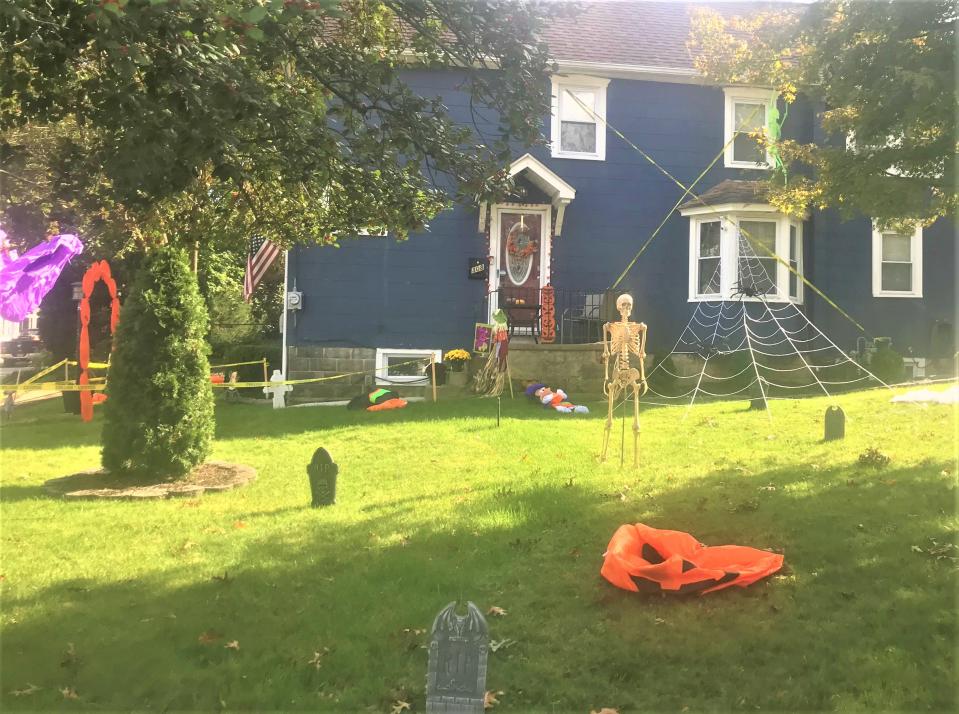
[550,75,609,161]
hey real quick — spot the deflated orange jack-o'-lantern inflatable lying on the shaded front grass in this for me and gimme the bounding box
[600,523,783,595]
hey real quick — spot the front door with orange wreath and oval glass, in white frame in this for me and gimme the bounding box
[490,206,550,315]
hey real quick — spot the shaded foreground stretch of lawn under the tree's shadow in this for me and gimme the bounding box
[2,454,957,712]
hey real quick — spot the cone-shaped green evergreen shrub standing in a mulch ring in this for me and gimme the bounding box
[103,247,214,478]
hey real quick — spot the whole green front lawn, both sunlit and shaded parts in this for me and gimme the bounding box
[0,391,959,713]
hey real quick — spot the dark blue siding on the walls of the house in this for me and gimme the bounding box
[290,71,955,354]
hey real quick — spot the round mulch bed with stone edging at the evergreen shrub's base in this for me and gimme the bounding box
[43,461,256,499]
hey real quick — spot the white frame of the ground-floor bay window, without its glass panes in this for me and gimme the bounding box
[683,204,805,305]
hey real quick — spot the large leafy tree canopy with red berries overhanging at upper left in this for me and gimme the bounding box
[0,0,550,248]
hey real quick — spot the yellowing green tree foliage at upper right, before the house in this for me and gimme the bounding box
[689,0,959,224]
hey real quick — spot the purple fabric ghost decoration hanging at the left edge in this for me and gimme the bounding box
[0,230,83,322]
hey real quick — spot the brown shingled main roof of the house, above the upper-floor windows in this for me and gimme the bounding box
[543,0,781,72]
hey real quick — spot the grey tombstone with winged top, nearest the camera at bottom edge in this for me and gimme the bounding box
[426,602,489,714]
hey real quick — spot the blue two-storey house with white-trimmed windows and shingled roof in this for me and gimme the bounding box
[284,2,956,396]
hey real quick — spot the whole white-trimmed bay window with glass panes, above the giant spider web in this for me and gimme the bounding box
[684,205,803,304]
